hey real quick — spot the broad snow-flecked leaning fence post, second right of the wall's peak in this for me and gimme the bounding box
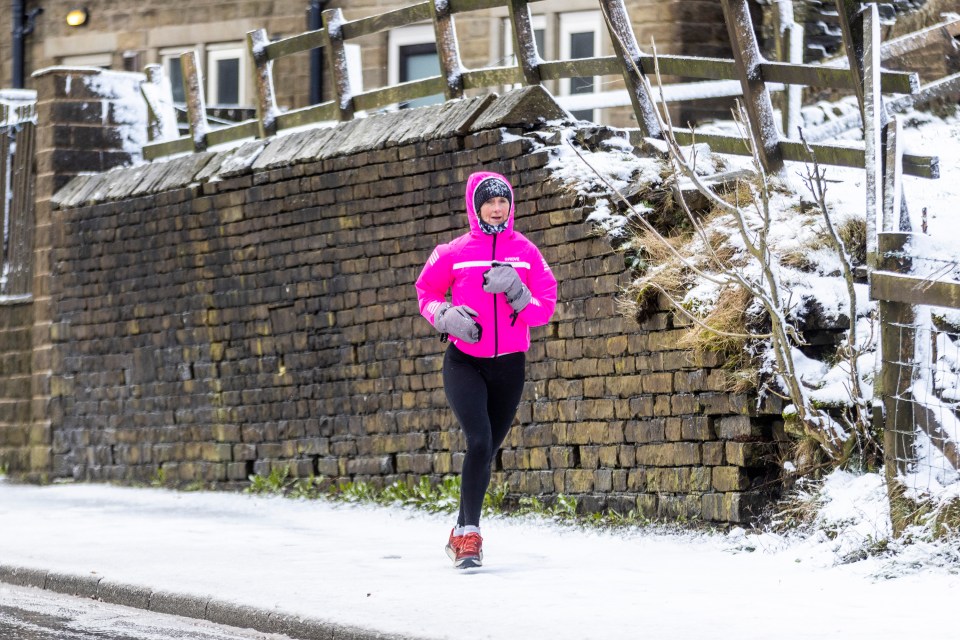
[721,0,783,173]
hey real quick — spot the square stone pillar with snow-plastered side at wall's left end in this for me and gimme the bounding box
[24,67,146,479]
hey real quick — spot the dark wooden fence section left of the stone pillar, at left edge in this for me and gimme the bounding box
[0,102,36,301]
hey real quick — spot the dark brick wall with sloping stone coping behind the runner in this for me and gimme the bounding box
[43,88,770,521]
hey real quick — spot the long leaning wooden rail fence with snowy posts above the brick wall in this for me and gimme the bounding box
[144,0,938,184]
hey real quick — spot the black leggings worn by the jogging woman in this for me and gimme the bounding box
[443,344,527,527]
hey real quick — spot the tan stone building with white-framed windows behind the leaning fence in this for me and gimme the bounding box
[0,0,736,125]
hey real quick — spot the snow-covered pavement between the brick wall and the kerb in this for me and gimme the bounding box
[0,480,960,640]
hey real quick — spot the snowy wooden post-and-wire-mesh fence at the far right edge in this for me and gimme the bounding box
[838,5,960,510]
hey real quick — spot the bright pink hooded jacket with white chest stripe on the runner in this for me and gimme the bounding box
[417,171,557,358]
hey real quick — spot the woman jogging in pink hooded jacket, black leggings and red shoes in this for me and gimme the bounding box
[417,172,557,569]
